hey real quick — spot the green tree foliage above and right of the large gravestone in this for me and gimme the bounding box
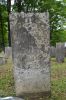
[14,0,66,45]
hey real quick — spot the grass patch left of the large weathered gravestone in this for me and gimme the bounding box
[0,60,15,97]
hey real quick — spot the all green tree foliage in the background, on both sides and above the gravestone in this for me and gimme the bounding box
[0,0,66,48]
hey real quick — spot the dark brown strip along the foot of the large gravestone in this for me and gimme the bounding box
[17,91,51,100]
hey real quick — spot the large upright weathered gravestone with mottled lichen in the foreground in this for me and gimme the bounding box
[10,12,50,99]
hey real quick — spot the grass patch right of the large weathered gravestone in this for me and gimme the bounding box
[51,59,66,100]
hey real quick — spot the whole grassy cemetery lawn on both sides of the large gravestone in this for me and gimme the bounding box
[0,58,66,100]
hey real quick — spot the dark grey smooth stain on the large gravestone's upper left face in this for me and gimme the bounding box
[17,27,37,49]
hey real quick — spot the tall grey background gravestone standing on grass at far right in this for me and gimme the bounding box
[56,43,64,63]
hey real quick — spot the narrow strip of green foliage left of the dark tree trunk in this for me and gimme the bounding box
[0,4,8,51]
